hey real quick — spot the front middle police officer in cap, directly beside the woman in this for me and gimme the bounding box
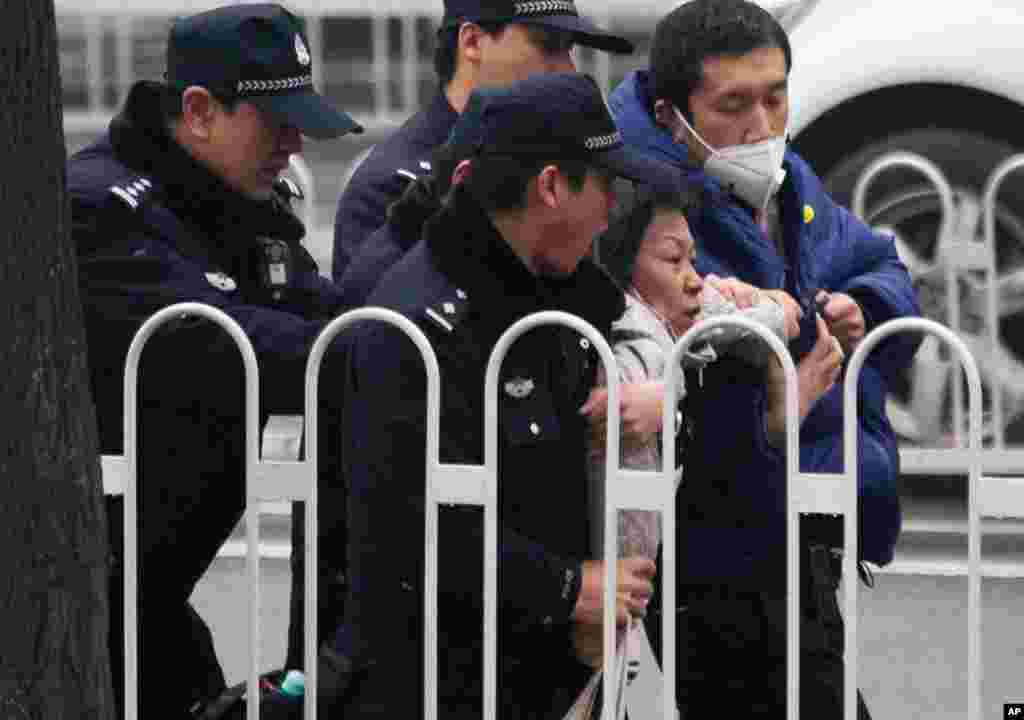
[334,74,676,720]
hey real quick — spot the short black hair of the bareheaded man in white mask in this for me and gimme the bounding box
[648,0,793,120]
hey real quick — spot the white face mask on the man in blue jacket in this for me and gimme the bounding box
[672,107,787,210]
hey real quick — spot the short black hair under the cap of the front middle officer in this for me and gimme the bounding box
[465,155,591,212]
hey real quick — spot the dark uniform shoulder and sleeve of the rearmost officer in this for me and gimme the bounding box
[331,90,459,282]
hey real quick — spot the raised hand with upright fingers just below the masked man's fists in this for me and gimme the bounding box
[765,315,845,448]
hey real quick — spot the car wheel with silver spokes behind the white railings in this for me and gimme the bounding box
[823,129,1024,447]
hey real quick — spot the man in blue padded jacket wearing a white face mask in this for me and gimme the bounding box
[610,0,919,717]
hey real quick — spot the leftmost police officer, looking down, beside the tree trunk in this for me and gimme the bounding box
[68,4,359,717]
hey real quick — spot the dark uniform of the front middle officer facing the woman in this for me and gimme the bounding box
[335,186,624,720]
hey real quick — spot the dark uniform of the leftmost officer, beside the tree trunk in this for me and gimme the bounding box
[68,83,352,717]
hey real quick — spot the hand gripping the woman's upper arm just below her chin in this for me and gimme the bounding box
[580,380,665,457]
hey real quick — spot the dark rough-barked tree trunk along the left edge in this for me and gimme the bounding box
[0,0,114,720]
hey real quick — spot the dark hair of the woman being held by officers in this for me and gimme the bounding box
[594,183,702,291]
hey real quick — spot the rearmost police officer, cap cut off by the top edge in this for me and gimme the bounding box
[332,0,633,282]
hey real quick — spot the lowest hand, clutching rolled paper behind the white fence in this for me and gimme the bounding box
[570,555,657,628]
